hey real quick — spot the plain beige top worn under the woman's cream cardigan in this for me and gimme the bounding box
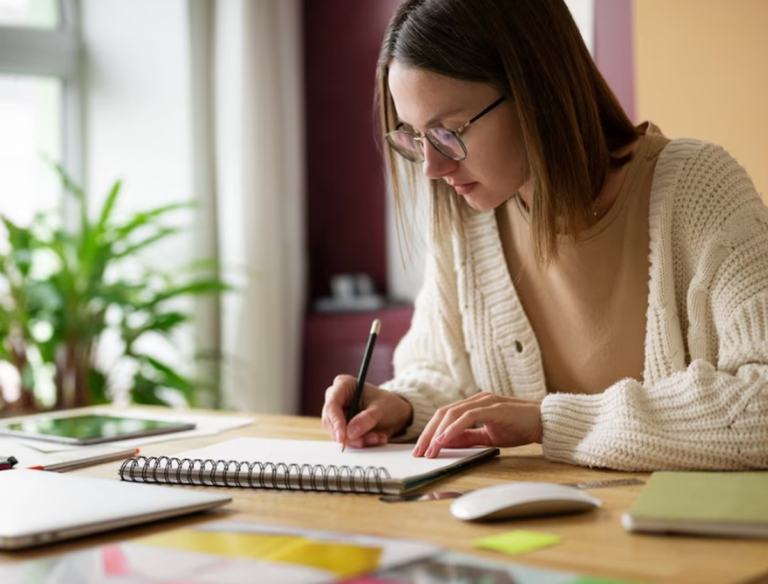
[497,125,669,393]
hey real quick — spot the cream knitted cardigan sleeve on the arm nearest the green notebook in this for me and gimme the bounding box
[542,145,768,471]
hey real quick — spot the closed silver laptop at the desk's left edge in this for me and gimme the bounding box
[0,469,232,550]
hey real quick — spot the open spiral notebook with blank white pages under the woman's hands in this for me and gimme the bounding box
[118,438,499,495]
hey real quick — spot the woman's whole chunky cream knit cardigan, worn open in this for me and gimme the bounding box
[383,140,768,471]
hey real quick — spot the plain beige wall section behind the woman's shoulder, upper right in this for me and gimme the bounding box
[633,0,768,203]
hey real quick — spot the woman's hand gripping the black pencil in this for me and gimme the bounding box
[322,375,413,448]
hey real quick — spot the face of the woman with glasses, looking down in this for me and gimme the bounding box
[389,61,527,211]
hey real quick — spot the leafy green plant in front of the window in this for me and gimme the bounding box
[0,166,229,413]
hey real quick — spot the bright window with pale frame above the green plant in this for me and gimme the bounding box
[0,0,82,224]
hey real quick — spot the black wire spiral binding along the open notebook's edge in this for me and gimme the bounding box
[119,456,391,493]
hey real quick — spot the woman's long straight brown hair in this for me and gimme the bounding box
[376,0,638,263]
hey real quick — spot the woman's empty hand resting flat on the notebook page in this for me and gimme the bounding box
[413,392,544,458]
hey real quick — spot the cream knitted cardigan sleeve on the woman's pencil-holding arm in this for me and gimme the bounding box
[381,226,478,441]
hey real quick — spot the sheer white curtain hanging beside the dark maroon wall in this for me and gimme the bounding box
[190,0,306,413]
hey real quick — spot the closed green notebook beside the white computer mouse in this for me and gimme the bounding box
[622,472,768,538]
